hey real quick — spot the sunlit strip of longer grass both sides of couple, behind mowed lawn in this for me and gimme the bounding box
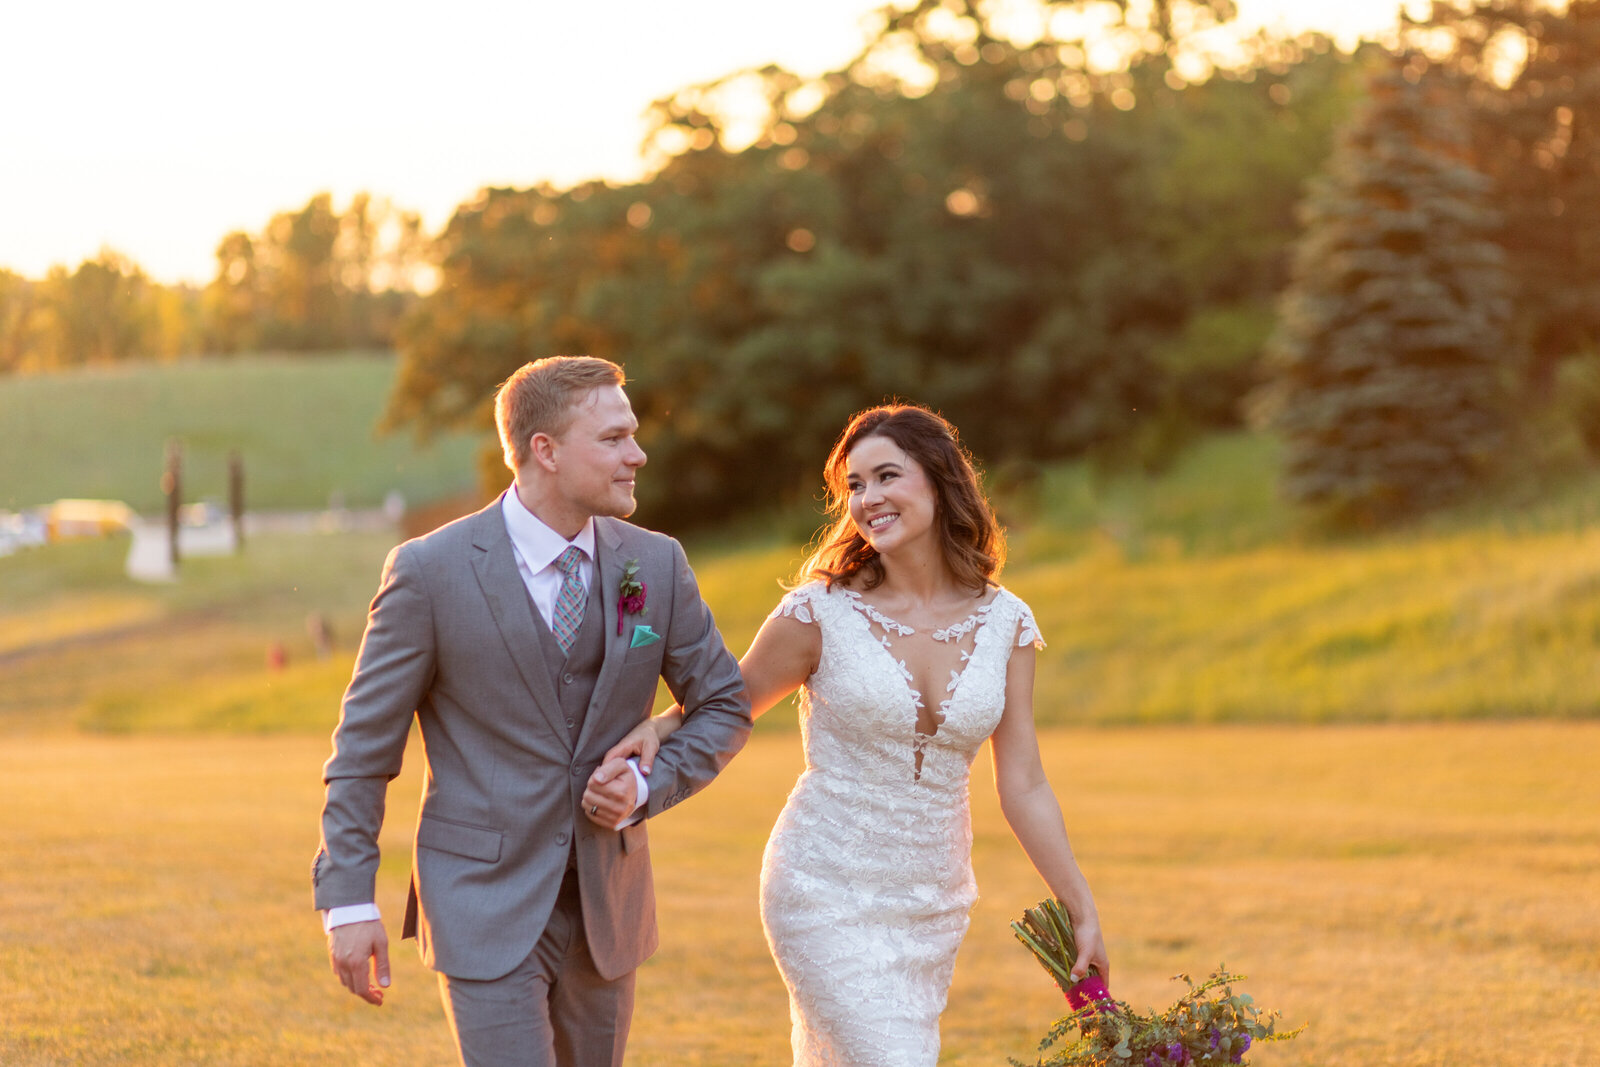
[15,476,1600,731]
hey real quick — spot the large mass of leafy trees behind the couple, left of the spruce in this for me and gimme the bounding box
[387,0,1360,523]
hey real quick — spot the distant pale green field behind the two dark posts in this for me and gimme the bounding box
[0,354,478,514]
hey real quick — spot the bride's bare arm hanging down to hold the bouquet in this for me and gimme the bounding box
[989,645,1110,982]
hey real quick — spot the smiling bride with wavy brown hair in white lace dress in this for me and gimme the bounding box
[606,405,1109,1067]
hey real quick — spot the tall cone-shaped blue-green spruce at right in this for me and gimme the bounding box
[1269,56,1510,522]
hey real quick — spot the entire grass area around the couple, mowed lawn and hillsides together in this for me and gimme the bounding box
[9,357,1600,1067]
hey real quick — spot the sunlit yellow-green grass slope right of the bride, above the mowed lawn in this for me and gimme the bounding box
[1013,530,1600,721]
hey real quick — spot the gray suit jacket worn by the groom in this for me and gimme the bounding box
[321,502,750,979]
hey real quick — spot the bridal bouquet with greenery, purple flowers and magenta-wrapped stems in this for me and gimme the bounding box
[1010,901,1304,1067]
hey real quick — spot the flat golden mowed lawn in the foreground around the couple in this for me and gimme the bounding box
[0,721,1600,1067]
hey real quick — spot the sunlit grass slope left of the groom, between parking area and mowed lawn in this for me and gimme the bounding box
[0,533,394,733]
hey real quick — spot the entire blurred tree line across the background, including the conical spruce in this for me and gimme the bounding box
[0,0,1600,523]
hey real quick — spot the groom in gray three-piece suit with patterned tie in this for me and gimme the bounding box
[312,357,750,1067]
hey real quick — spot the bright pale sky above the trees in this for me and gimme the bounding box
[0,0,1397,283]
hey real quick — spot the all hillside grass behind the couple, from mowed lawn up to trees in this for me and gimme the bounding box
[0,355,1600,731]
